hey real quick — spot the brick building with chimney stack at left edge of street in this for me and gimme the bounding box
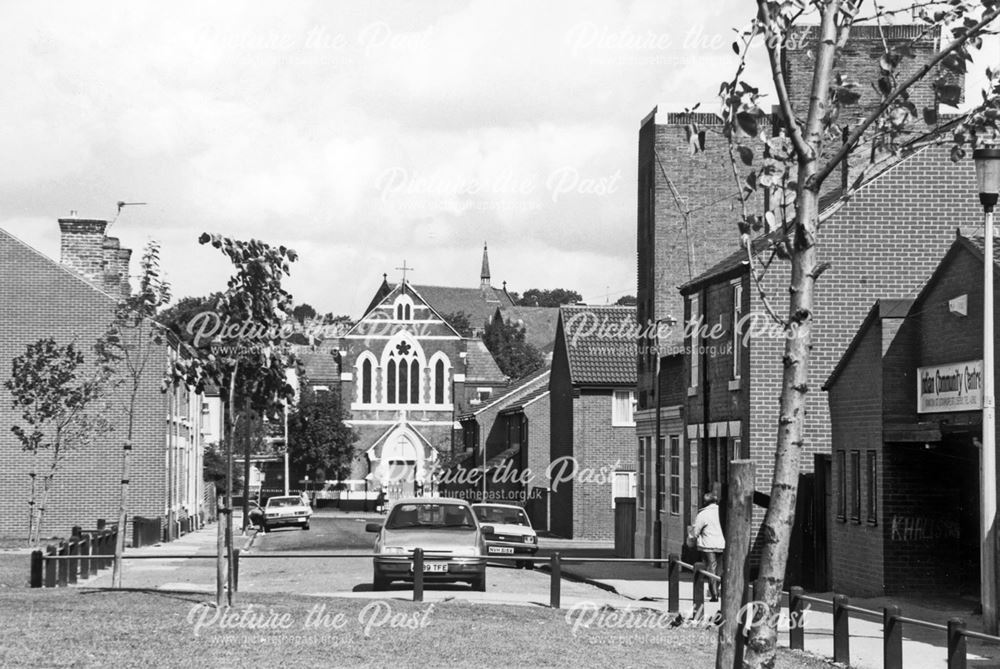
[0,218,204,537]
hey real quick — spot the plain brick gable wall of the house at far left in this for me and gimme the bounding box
[0,230,178,537]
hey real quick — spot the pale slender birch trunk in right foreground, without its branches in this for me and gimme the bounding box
[744,184,819,669]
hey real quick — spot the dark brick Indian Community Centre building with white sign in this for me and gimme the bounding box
[824,236,1000,596]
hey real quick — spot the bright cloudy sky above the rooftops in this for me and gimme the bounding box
[0,0,994,316]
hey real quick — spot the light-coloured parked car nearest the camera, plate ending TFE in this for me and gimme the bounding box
[367,497,492,592]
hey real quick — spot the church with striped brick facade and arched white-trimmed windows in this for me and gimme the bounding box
[336,246,513,499]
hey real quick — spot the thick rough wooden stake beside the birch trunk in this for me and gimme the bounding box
[713,460,754,669]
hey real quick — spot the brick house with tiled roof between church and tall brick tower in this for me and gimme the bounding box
[546,306,636,539]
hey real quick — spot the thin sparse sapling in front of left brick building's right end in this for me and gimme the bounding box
[97,241,170,588]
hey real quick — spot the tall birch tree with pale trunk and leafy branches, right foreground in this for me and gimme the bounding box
[708,0,1000,667]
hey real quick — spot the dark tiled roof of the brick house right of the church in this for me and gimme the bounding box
[559,305,638,387]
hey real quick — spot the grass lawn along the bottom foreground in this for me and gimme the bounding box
[0,588,829,669]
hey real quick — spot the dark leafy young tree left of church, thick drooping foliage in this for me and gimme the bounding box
[165,233,298,606]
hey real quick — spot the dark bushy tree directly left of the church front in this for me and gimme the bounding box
[288,384,357,481]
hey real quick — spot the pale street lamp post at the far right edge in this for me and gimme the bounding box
[972,148,1000,634]
